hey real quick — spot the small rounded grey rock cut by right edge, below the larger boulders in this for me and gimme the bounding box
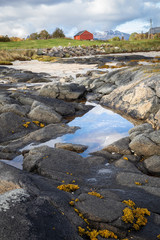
[144,155,160,175]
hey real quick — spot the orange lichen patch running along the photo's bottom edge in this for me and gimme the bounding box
[78,227,118,240]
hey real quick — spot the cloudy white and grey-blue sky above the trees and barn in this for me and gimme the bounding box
[0,0,160,37]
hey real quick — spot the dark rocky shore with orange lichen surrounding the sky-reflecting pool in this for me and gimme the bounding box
[0,56,160,240]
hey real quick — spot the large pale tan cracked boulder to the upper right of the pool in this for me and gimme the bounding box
[101,66,160,120]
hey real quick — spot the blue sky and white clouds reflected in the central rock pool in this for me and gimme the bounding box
[28,102,133,157]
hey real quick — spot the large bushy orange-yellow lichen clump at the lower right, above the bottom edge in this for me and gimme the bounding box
[122,200,150,231]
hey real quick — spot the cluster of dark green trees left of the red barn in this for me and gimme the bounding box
[27,28,65,40]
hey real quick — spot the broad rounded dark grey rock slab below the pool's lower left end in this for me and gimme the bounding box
[23,146,96,181]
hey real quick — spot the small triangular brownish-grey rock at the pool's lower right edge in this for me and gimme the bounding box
[103,137,131,155]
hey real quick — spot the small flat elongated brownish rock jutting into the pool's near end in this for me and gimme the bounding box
[55,143,88,153]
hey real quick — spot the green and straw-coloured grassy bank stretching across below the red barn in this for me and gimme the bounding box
[0,39,160,65]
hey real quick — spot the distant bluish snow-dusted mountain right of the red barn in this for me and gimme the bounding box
[93,30,130,40]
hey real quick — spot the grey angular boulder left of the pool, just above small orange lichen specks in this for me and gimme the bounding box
[28,105,62,123]
